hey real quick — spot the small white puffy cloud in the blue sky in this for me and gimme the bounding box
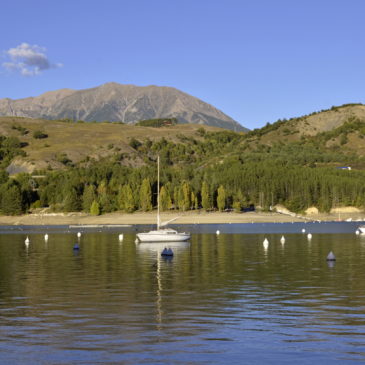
[2,43,63,76]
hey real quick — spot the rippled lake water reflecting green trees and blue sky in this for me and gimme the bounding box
[0,222,365,364]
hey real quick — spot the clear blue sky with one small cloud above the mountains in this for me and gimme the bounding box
[0,0,365,129]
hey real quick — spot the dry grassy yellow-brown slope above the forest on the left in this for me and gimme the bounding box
[0,117,222,174]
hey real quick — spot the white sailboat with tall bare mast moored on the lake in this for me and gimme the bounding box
[137,156,190,242]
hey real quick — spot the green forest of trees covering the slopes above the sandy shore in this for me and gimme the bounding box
[0,120,365,215]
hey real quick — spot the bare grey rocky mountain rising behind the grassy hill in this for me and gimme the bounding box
[0,82,248,132]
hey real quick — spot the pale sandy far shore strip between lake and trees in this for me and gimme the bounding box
[0,211,365,226]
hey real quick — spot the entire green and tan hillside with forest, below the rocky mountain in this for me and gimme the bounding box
[0,106,365,214]
